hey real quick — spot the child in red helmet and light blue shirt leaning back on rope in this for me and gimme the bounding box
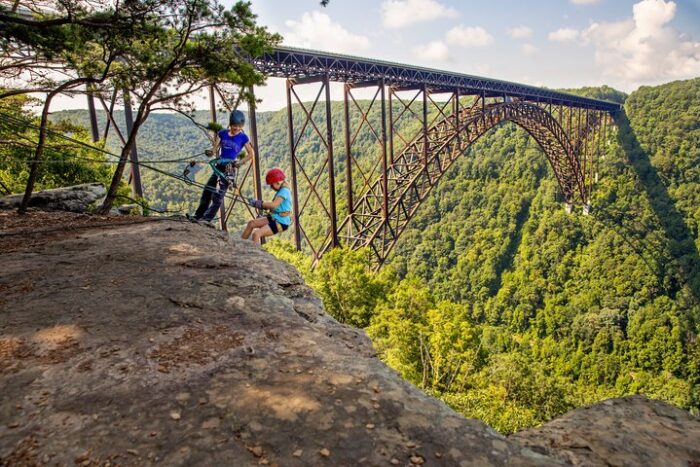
[243,168,292,245]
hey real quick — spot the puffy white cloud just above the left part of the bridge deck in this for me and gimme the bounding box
[284,11,370,53]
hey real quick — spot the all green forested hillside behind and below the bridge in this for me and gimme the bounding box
[41,79,700,432]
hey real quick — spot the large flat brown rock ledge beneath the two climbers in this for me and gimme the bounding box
[0,213,699,466]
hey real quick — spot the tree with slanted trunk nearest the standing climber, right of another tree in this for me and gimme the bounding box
[101,0,280,213]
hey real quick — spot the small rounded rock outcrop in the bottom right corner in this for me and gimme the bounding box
[510,396,700,467]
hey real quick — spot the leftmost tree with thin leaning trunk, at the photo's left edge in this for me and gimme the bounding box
[0,0,167,212]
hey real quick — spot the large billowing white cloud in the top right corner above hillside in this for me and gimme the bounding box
[582,0,700,90]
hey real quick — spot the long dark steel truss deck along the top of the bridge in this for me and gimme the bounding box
[254,47,620,112]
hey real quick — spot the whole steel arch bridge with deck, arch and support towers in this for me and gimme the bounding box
[80,47,621,268]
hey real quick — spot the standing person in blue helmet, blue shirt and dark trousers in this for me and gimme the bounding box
[190,110,255,226]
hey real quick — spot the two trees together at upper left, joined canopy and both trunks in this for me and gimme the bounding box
[0,0,279,211]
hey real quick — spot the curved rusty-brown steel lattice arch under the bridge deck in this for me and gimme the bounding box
[330,100,588,267]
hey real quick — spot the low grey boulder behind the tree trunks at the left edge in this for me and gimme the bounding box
[0,183,107,212]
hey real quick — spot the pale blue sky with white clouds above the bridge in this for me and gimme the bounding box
[222,0,700,110]
